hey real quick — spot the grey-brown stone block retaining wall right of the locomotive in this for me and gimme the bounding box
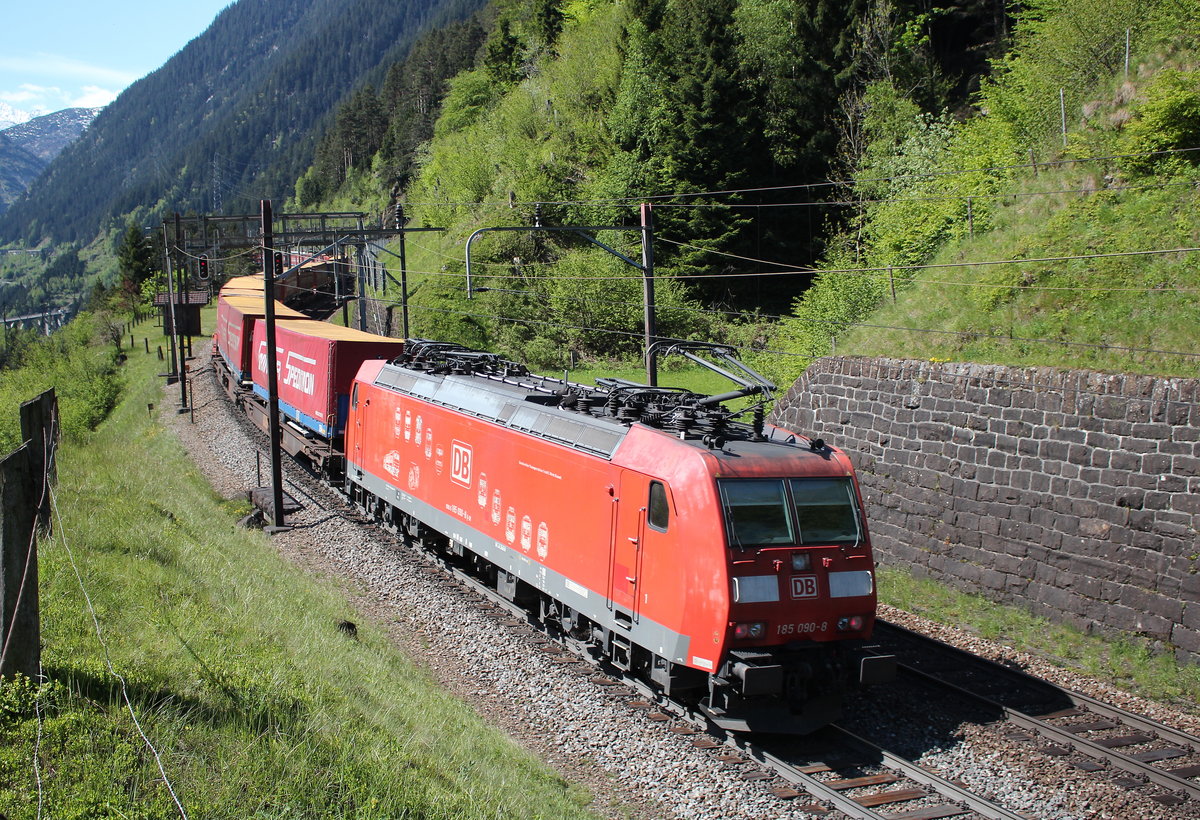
[772,358,1200,662]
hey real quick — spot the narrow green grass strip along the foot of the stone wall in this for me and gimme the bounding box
[878,569,1200,713]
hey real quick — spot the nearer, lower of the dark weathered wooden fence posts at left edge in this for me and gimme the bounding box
[0,443,42,681]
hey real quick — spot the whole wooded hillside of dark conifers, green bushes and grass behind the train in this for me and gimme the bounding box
[290,0,1200,383]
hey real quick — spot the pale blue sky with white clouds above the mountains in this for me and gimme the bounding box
[0,0,233,121]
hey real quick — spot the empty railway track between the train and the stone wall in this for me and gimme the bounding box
[875,621,1200,812]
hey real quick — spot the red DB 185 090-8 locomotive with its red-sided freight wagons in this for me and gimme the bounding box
[215,277,894,734]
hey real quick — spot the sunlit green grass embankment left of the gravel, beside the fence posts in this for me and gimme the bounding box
[0,328,600,820]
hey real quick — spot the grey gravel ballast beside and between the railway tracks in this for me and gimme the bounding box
[162,351,1200,820]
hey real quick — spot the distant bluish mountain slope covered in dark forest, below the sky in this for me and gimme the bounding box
[0,0,481,241]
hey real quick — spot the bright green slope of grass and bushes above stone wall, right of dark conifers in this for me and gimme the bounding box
[762,0,1200,384]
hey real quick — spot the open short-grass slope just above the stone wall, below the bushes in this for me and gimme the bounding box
[838,172,1200,377]
